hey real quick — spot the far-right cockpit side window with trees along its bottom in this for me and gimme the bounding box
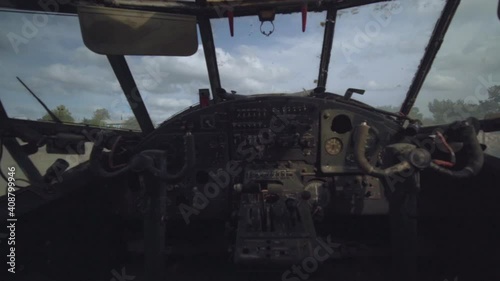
[415,0,500,125]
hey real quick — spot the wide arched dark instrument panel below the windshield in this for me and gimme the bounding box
[140,96,400,174]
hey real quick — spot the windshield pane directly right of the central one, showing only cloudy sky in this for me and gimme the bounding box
[326,0,445,107]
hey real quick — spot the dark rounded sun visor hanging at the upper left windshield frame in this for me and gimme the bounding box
[78,6,198,56]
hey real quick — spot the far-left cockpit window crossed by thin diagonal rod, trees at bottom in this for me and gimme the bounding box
[0,11,139,129]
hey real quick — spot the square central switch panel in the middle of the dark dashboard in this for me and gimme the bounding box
[231,101,318,163]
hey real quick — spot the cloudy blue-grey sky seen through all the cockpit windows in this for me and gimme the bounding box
[0,0,500,122]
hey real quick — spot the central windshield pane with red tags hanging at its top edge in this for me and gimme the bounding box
[212,12,326,94]
